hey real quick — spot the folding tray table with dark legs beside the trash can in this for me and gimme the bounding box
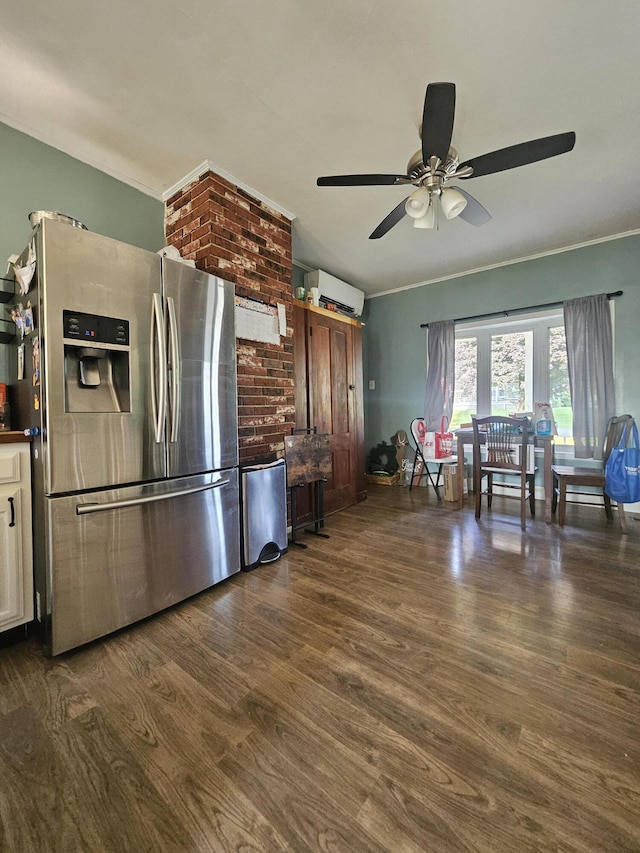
[284,427,332,548]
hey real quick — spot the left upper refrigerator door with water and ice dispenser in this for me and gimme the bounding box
[36,220,166,494]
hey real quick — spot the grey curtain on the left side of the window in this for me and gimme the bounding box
[424,320,456,431]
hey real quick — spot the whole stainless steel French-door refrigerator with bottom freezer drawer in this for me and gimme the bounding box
[15,219,240,655]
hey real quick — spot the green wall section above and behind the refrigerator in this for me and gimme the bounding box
[0,123,164,381]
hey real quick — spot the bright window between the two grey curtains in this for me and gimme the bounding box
[451,309,573,444]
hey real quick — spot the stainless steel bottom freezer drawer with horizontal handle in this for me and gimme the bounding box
[46,468,240,655]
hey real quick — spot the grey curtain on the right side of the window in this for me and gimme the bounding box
[564,294,616,459]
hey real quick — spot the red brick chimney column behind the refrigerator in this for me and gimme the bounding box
[165,171,295,464]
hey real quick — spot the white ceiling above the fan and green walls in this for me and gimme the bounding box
[0,0,640,295]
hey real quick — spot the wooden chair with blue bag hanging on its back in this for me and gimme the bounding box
[551,415,633,533]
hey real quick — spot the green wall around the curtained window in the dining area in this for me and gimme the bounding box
[363,235,640,451]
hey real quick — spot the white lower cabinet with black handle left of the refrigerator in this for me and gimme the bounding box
[0,442,33,631]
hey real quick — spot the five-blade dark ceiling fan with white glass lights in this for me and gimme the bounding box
[317,83,576,240]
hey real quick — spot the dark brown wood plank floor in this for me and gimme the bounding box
[0,487,640,853]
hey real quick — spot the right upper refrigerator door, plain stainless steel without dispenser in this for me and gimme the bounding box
[162,258,238,477]
